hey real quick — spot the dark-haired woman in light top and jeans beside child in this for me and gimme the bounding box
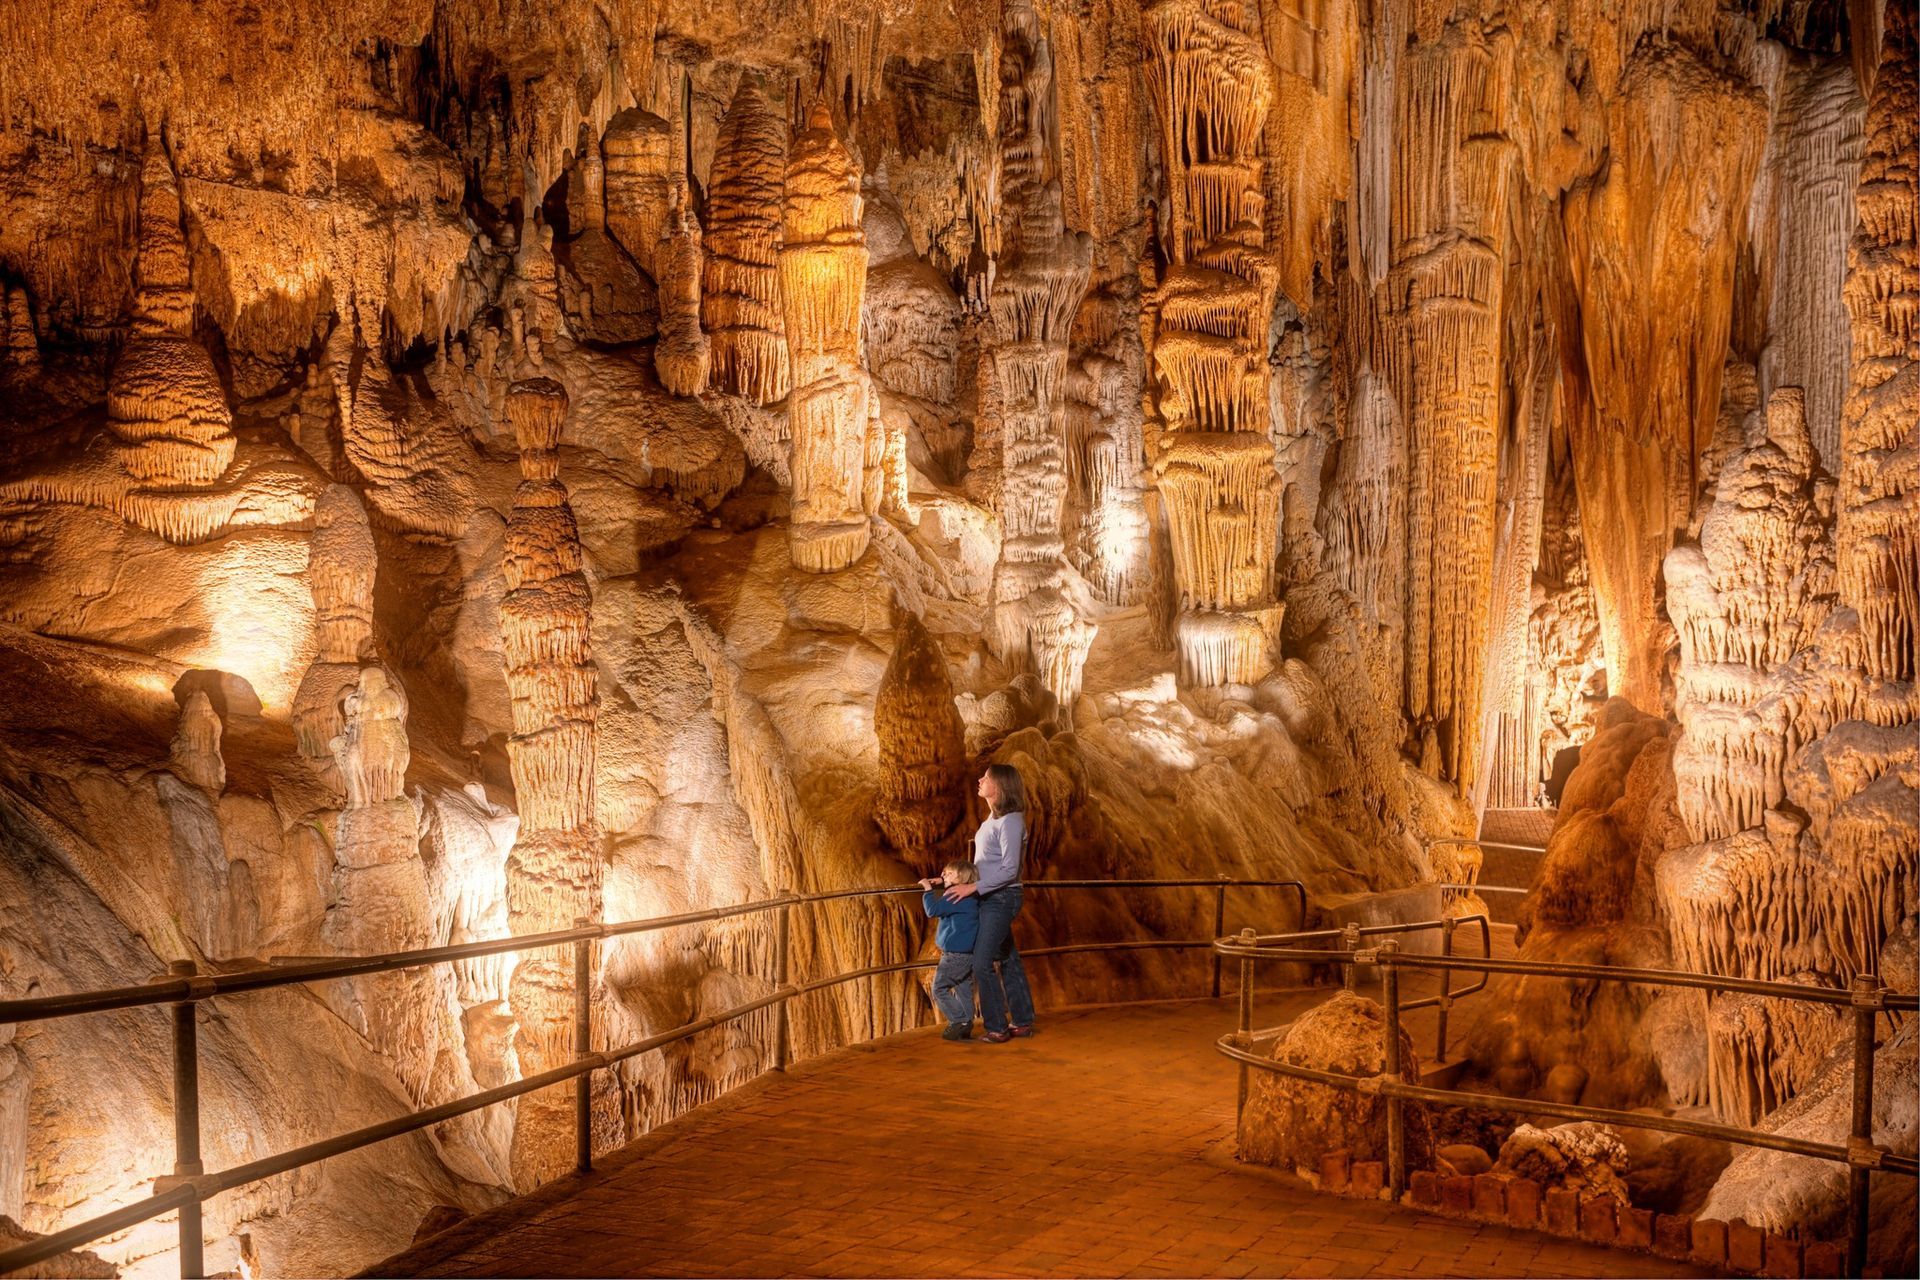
[947,764,1033,1044]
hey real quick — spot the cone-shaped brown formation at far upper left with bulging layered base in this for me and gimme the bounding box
[108,138,234,489]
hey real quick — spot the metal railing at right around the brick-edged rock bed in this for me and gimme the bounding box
[1213,921,1920,1276]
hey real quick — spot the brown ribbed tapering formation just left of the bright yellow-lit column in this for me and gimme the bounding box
[701,77,791,405]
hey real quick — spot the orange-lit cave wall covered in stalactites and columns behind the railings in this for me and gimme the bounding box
[0,0,1920,1272]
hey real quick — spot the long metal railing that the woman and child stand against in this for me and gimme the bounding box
[0,877,1308,1280]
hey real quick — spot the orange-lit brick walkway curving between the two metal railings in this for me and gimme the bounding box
[369,996,1711,1276]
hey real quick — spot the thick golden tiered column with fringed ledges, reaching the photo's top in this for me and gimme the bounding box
[1144,0,1281,685]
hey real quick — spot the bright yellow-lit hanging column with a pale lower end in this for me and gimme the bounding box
[780,102,872,574]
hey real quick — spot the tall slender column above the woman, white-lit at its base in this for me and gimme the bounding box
[989,2,1094,708]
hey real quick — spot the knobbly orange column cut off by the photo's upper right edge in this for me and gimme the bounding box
[1836,4,1920,681]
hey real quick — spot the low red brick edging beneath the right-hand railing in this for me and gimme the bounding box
[1315,1151,1847,1280]
